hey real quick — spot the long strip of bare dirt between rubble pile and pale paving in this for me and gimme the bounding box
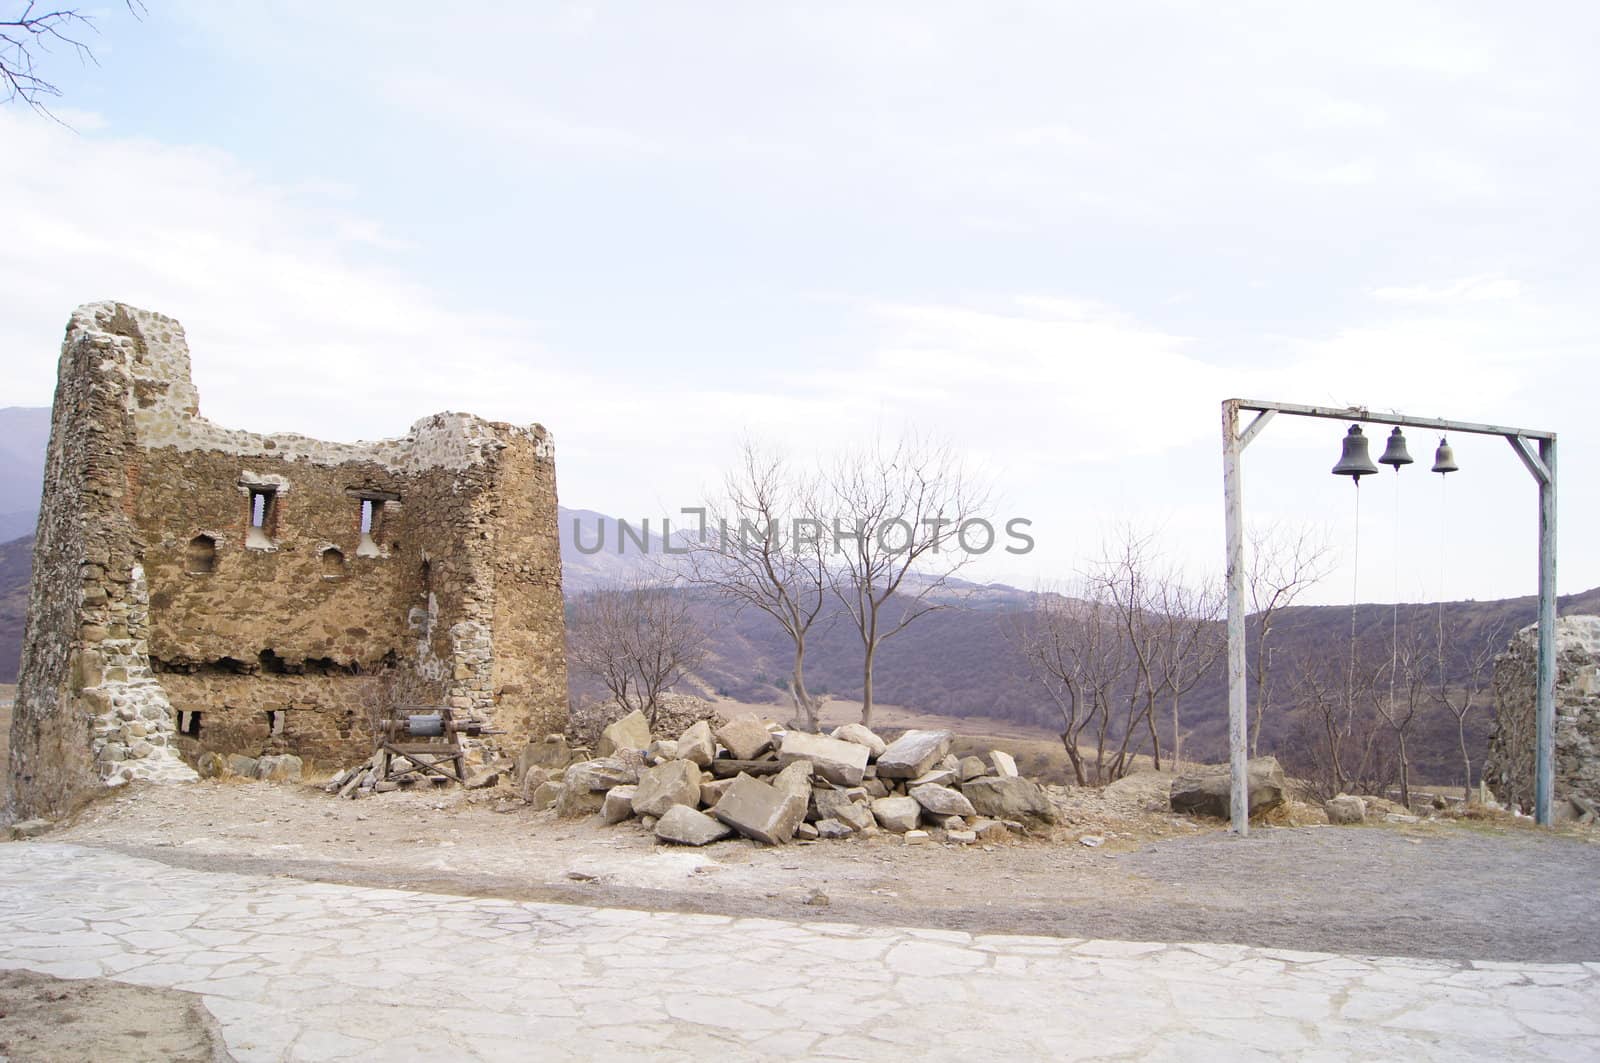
[14,776,1600,962]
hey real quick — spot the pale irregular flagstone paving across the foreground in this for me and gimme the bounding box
[0,842,1600,1063]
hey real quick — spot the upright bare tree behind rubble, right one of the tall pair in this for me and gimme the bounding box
[827,435,995,727]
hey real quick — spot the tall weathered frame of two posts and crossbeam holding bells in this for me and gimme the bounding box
[1222,399,1555,834]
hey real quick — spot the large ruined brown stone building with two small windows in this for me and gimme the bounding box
[10,303,566,818]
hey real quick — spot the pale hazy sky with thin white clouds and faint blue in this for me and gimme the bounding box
[0,0,1600,602]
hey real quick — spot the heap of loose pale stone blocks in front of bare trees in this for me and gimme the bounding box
[517,712,1056,845]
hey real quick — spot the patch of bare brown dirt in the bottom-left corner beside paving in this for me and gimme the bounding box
[0,970,234,1063]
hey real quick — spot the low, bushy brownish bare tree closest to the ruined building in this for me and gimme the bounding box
[566,580,706,727]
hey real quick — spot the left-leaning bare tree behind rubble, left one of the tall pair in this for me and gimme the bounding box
[682,442,829,730]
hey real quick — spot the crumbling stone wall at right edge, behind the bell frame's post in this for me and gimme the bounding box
[1483,616,1600,812]
